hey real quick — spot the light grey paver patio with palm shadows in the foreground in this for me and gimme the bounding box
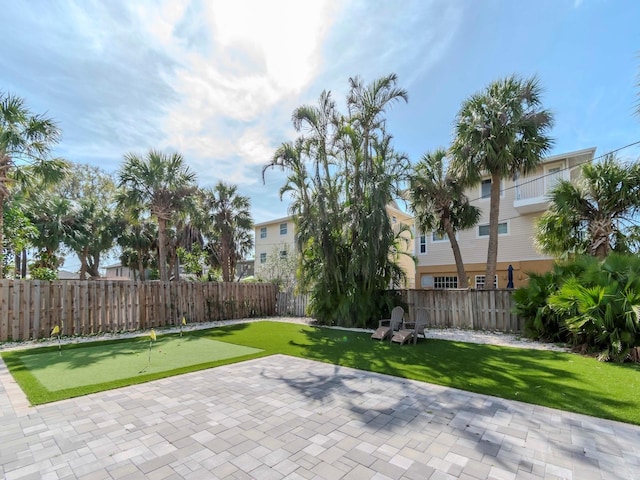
[0,355,640,480]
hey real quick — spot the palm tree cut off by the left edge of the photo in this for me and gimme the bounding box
[0,92,66,274]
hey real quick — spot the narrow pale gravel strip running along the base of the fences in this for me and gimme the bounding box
[0,317,569,352]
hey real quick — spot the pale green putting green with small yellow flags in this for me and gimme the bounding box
[20,336,262,392]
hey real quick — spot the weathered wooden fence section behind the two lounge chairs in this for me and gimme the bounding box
[400,289,524,332]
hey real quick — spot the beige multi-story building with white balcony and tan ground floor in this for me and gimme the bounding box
[415,148,596,288]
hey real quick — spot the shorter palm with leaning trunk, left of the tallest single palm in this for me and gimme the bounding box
[409,149,480,288]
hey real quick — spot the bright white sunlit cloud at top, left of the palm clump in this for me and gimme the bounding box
[123,0,342,181]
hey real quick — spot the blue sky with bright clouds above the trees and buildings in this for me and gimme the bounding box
[0,0,640,270]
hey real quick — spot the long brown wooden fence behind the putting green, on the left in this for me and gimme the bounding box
[0,280,276,341]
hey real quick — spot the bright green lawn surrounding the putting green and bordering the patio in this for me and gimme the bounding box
[2,322,640,425]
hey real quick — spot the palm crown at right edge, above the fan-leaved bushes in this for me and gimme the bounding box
[536,155,640,259]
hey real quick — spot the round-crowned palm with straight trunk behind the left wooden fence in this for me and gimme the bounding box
[118,149,197,282]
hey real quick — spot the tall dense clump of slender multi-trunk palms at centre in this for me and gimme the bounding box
[263,74,408,326]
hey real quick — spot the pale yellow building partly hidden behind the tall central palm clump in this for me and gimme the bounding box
[255,205,415,288]
